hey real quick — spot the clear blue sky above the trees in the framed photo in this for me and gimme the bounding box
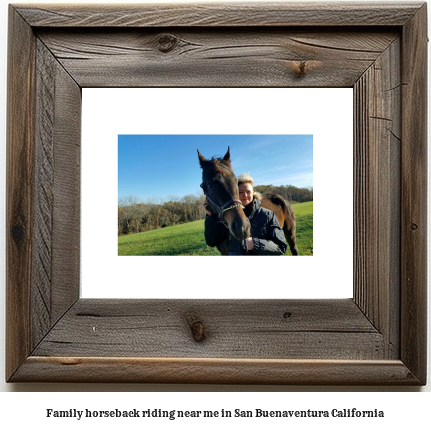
[118,135,313,201]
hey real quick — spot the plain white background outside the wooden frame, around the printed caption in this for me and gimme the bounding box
[0,0,431,422]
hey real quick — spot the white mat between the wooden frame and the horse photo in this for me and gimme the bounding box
[81,88,353,299]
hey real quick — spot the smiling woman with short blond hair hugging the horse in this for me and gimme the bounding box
[204,174,287,256]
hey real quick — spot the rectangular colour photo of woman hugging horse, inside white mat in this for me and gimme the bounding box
[118,135,313,256]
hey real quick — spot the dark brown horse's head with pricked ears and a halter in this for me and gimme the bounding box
[198,147,250,240]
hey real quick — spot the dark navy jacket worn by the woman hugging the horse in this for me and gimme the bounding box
[205,198,287,256]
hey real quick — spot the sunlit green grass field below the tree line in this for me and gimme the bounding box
[118,202,313,256]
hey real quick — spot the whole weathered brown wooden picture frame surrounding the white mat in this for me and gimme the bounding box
[6,2,427,385]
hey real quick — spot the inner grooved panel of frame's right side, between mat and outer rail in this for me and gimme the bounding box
[354,38,402,358]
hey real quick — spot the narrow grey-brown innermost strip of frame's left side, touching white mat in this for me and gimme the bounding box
[51,53,81,323]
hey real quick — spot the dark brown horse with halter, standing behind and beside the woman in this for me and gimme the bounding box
[198,147,299,256]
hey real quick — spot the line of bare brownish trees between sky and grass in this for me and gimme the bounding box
[118,185,313,235]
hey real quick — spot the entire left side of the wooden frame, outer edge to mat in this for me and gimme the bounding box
[6,9,81,382]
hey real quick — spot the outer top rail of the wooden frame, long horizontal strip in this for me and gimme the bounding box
[16,2,421,28]
